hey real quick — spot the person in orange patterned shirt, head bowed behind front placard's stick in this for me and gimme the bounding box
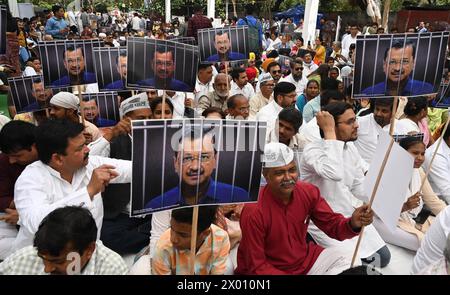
[152,206,230,275]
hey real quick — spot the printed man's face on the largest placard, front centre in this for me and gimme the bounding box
[174,135,216,187]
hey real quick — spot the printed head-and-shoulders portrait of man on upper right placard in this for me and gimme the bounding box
[362,39,434,96]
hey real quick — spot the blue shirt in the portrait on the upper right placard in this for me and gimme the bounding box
[362,78,436,96]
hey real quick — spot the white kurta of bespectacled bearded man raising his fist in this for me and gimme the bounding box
[300,140,385,258]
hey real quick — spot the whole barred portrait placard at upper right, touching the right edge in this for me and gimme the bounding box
[353,32,449,98]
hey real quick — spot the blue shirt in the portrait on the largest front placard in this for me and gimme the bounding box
[145,180,250,210]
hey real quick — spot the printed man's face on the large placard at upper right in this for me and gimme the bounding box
[383,46,414,83]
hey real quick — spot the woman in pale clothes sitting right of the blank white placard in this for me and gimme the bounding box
[373,136,446,251]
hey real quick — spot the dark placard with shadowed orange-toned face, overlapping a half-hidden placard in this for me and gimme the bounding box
[126,37,199,92]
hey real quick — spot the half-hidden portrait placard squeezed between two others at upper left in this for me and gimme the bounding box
[93,47,127,91]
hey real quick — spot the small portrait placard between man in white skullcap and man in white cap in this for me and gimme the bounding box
[81,92,120,128]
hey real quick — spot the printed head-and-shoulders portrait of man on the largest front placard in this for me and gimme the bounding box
[145,128,249,210]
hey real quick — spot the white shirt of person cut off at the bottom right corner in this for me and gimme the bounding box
[411,206,450,274]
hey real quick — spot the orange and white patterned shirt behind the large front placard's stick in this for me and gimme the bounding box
[152,224,230,275]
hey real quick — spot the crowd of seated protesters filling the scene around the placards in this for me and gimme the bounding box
[0,5,450,275]
